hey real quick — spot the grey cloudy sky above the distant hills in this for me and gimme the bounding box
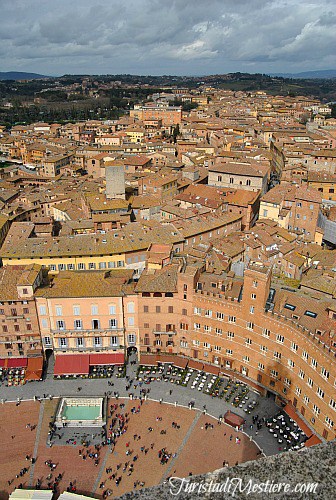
[0,0,336,75]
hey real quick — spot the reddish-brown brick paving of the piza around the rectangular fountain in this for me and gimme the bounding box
[0,398,260,498]
